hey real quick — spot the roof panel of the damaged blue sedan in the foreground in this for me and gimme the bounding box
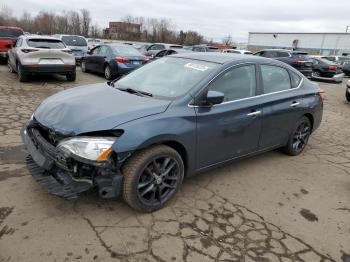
[172,52,281,64]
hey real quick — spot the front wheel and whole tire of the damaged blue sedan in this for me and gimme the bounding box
[122,145,185,212]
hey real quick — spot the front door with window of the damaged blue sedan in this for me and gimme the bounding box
[195,64,262,169]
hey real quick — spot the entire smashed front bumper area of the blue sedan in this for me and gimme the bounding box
[21,124,123,199]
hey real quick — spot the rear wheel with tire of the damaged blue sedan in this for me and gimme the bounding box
[283,116,311,156]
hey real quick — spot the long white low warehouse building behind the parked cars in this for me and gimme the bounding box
[248,32,350,55]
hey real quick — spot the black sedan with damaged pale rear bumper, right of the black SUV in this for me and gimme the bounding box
[310,57,344,82]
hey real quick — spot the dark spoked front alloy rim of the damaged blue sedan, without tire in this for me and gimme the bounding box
[137,156,181,204]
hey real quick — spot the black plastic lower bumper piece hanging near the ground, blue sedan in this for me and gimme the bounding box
[26,156,92,199]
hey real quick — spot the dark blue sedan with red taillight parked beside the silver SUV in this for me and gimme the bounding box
[81,44,148,80]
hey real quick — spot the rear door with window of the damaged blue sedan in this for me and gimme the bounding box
[259,64,304,149]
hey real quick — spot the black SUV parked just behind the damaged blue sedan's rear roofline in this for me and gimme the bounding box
[254,49,312,78]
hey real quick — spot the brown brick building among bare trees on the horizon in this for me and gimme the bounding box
[103,22,141,40]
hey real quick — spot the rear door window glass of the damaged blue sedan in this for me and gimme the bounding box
[261,65,291,94]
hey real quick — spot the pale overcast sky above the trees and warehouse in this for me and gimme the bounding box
[0,0,350,42]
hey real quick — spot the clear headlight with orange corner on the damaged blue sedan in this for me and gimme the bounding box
[58,137,117,161]
